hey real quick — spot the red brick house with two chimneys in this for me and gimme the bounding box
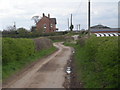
[36,13,58,33]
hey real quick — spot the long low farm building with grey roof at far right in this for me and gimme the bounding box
[90,25,120,33]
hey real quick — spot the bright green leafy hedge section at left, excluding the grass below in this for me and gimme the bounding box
[2,38,36,64]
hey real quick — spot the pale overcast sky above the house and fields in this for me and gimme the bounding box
[0,0,119,30]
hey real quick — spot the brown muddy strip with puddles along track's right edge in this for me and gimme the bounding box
[64,49,84,90]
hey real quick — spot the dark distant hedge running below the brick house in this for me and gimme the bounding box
[2,30,68,38]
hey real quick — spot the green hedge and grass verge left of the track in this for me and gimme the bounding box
[2,38,56,81]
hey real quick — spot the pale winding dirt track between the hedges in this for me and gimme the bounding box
[5,43,72,88]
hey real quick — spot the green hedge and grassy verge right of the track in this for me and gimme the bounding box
[65,36,120,88]
